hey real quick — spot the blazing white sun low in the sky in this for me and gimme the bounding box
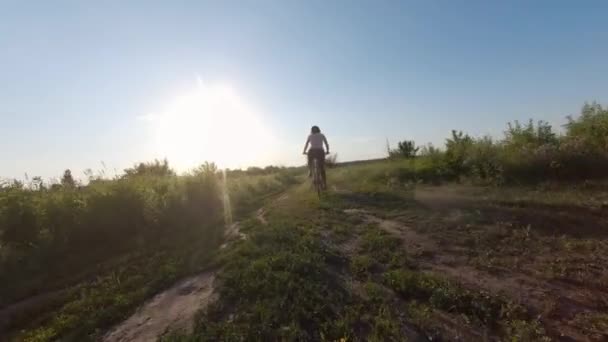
[153,82,272,170]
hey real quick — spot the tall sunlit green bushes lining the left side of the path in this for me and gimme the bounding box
[0,161,296,304]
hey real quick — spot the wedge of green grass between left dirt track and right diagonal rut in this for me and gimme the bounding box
[166,178,560,341]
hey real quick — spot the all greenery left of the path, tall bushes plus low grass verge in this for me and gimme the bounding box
[0,163,299,341]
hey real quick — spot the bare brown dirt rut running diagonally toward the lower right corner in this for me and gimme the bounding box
[344,209,608,341]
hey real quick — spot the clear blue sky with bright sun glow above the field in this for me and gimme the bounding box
[0,0,608,178]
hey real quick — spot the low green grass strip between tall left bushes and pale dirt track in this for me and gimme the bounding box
[17,238,214,341]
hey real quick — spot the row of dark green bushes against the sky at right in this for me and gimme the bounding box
[376,103,608,184]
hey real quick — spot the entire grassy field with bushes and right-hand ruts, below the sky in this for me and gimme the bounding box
[0,103,608,341]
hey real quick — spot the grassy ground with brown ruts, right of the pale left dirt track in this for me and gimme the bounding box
[163,162,608,341]
